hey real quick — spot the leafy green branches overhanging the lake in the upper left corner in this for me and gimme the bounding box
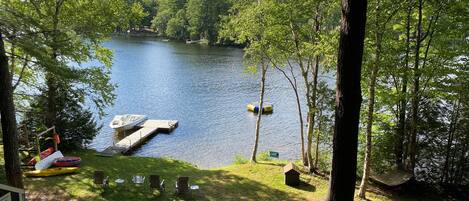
[0,0,126,118]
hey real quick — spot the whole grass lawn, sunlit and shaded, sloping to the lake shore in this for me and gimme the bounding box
[0,147,444,201]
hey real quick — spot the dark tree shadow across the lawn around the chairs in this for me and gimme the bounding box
[25,151,308,200]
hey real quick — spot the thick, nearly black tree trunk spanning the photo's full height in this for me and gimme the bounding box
[326,0,367,201]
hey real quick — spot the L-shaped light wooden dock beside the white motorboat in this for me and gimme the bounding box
[98,119,178,156]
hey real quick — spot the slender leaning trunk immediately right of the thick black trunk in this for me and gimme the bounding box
[358,0,384,196]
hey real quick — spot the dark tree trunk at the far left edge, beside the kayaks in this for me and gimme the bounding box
[0,33,23,188]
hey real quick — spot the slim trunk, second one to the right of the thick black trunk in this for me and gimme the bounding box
[394,1,412,169]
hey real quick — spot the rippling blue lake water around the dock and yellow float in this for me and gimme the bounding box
[90,38,312,168]
